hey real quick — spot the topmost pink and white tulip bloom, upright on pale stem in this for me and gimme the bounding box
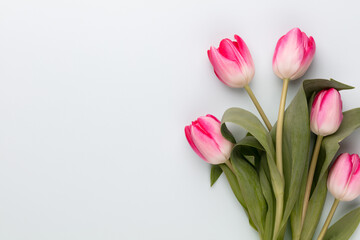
[273,28,316,80]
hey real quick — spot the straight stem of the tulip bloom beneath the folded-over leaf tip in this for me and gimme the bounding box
[301,135,323,228]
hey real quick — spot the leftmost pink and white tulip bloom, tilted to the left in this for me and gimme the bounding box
[185,114,233,164]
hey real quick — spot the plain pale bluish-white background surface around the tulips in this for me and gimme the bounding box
[0,0,360,240]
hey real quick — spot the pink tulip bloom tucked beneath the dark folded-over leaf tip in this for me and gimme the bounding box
[310,88,343,136]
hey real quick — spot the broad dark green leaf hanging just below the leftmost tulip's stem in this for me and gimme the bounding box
[231,154,267,233]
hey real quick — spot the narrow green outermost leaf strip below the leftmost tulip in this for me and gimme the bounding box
[219,164,257,231]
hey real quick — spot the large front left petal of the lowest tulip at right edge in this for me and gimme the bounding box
[327,153,352,200]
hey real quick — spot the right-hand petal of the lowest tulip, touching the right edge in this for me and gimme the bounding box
[342,154,360,201]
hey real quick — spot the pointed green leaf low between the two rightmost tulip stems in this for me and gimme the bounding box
[297,172,327,240]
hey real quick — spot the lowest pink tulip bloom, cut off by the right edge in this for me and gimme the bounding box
[327,153,360,201]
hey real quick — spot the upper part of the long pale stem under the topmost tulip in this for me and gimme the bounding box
[276,78,289,177]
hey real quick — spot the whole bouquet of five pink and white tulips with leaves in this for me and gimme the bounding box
[185,28,360,240]
